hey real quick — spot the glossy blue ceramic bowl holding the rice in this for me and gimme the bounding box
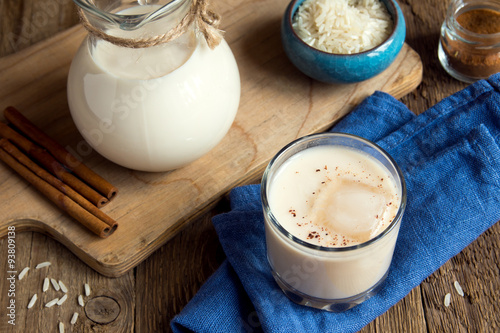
[281,0,406,83]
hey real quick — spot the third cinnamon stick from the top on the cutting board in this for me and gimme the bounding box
[0,139,118,233]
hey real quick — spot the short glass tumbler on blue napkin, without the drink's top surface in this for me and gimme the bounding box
[261,133,406,312]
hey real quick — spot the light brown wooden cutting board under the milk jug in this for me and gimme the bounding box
[0,0,422,276]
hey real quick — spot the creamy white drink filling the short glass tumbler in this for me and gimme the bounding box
[266,146,401,299]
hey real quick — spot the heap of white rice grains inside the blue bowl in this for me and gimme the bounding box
[292,0,394,54]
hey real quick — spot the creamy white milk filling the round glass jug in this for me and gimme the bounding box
[68,5,240,171]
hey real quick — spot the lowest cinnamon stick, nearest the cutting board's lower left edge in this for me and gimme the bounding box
[0,148,114,238]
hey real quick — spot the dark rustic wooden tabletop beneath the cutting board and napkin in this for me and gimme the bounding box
[0,0,500,332]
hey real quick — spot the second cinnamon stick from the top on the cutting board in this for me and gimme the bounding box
[0,121,108,207]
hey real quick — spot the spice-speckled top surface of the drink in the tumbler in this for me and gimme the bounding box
[269,146,401,247]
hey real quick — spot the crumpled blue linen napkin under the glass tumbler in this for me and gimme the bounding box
[171,74,500,332]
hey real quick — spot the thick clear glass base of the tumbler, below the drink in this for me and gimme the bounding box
[272,271,389,313]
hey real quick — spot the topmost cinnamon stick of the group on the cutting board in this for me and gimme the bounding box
[4,106,118,200]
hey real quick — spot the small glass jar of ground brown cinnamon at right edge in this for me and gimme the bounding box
[438,0,500,83]
